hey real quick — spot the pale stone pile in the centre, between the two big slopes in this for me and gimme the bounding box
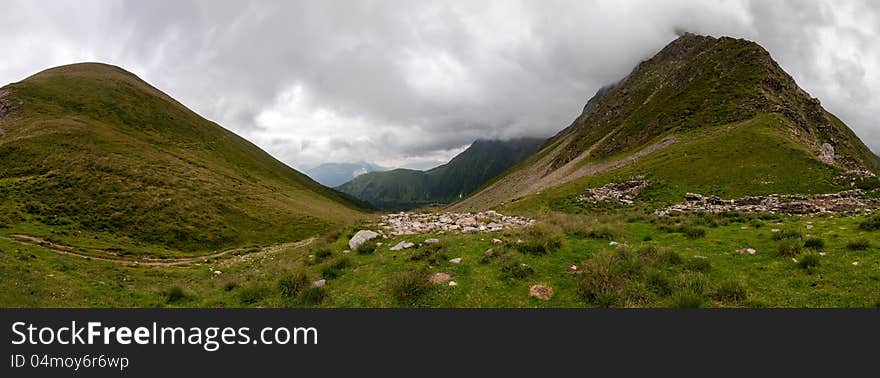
[379,211,535,236]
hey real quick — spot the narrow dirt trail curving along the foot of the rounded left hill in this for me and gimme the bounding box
[4,234,315,266]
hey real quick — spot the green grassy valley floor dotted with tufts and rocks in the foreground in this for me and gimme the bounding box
[0,211,880,307]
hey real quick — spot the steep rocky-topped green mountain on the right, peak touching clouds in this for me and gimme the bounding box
[452,34,880,210]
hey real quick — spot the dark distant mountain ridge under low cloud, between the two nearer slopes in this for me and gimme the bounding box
[337,138,543,210]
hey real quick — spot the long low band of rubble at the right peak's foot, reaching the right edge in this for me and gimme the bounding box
[655,189,880,215]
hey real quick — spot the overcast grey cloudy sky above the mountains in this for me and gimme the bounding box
[0,0,880,169]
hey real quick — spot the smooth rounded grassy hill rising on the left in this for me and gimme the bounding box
[0,63,360,251]
